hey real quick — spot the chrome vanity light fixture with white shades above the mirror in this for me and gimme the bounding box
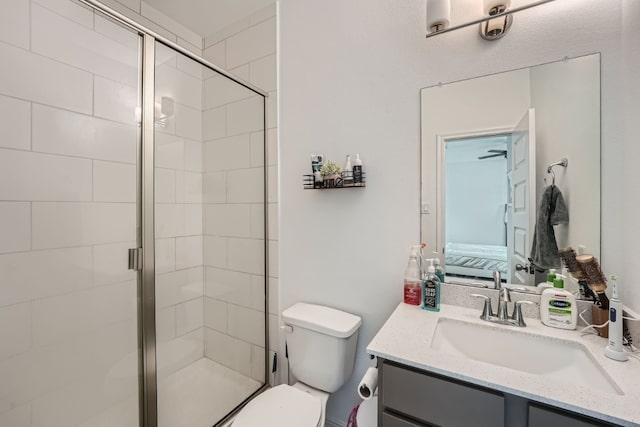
[427,0,554,40]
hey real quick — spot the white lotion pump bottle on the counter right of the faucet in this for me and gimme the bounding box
[540,274,578,329]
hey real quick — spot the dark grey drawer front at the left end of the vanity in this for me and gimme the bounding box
[381,361,505,427]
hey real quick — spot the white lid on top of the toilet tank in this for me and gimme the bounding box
[282,302,362,338]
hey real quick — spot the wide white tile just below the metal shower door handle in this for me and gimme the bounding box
[33,281,138,345]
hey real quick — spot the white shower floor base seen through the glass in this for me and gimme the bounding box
[82,358,261,427]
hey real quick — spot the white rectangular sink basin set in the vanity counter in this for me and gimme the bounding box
[431,318,624,395]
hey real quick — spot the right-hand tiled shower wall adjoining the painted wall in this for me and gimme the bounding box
[203,3,283,383]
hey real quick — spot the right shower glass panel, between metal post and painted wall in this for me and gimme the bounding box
[155,43,266,427]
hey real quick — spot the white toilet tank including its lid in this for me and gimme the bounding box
[282,303,361,393]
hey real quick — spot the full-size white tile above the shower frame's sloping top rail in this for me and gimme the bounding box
[227,17,276,68]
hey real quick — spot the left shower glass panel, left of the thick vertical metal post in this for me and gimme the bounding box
[0,0,140,427]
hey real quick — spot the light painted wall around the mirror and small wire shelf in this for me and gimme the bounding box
[279,0,640,420]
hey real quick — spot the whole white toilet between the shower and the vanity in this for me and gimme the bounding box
[232,303,361,427]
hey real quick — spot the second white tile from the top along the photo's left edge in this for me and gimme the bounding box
[0,43,93,114]
